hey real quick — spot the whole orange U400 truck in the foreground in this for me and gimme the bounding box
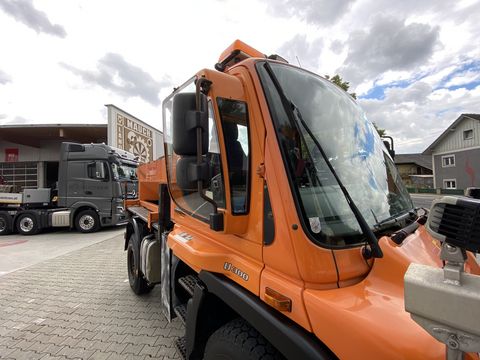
[125,41,479,360]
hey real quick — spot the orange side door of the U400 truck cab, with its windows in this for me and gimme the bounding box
[164,70,263,293]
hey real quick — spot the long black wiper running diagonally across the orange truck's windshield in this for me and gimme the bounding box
[264,62,383,258]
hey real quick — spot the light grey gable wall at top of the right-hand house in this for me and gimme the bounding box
[435,118,480,154]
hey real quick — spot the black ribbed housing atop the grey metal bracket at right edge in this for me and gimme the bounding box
[429,199,480,252]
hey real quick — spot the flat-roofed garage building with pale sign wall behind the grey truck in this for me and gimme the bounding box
[0,105,163,191]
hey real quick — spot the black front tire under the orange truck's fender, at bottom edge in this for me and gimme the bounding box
[204,319,285,360]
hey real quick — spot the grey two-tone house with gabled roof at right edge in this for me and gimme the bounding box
[423,114,480,189]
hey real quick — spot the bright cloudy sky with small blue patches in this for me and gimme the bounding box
[0,0,480,153]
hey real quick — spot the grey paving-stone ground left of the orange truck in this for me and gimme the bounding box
[0,235,183,360]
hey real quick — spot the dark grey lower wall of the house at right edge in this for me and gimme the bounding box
[433,148,480,189]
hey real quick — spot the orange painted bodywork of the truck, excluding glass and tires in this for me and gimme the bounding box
[127,42,480,359]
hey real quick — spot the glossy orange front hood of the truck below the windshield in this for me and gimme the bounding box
[304,226,480,359]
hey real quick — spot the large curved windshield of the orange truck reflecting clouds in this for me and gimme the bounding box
[257,62,413,246]
